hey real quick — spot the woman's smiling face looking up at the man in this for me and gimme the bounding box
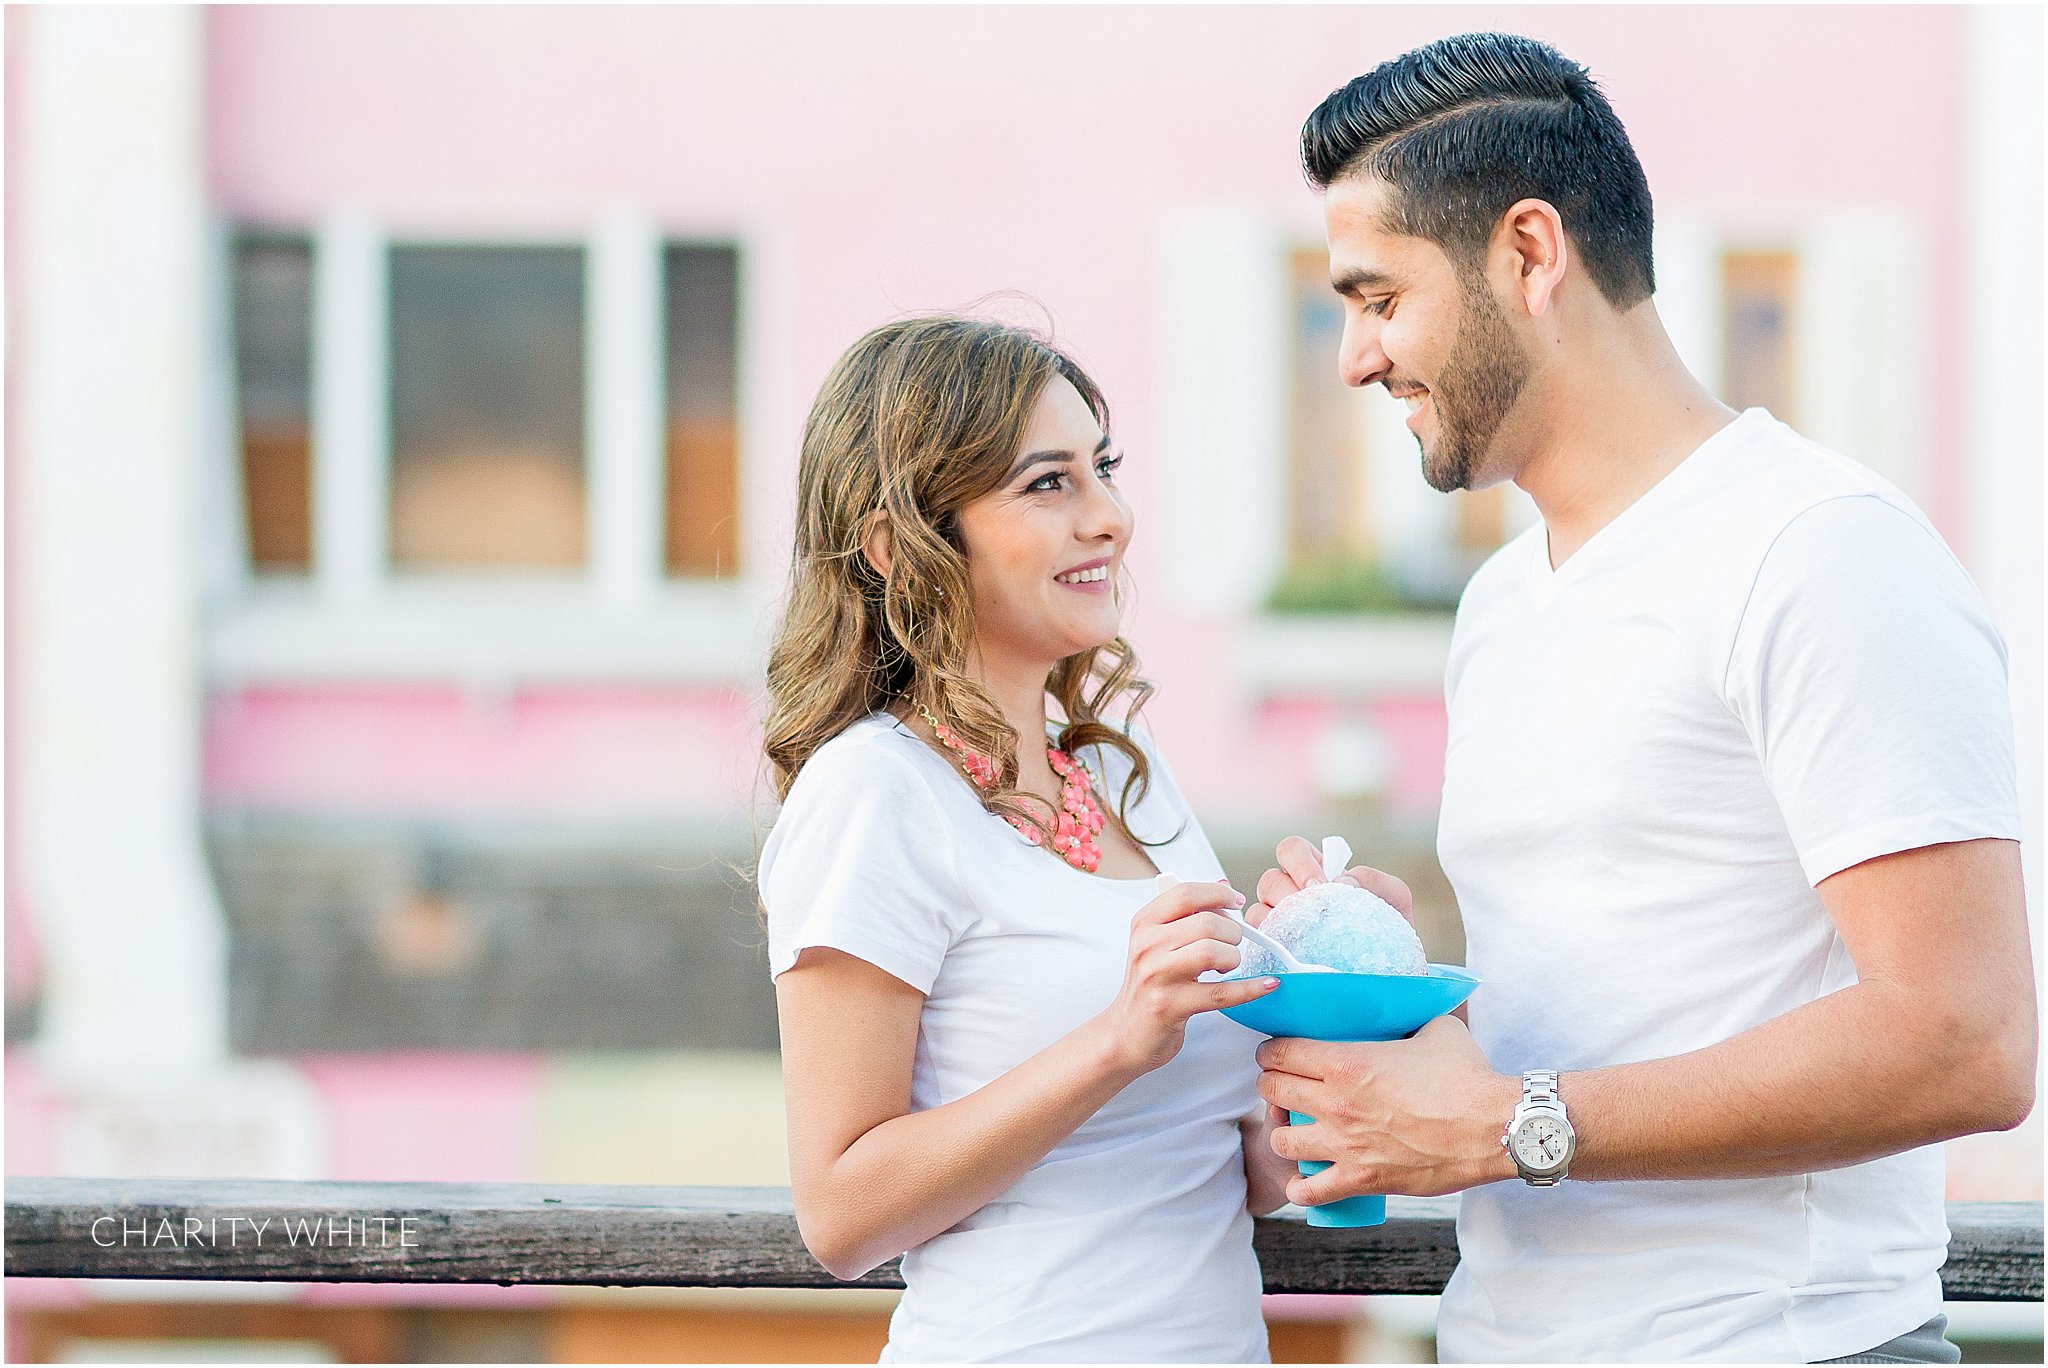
[958,375,1133,670]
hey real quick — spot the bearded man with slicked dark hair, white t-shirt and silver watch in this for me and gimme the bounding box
[1253,35,2036,1362]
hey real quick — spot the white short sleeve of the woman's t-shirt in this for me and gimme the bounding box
[760,743,965,993]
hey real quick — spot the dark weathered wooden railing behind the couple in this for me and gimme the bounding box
[6,1178,2042,1300]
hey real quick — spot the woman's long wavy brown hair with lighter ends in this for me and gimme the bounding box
[762,315,1171,846]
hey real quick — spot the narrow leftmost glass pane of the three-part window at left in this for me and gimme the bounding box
[233,236,313,575]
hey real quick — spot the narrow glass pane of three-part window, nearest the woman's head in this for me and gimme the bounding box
[664,244,739,578]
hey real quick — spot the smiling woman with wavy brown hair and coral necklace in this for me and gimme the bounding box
[760,317,1288,1362]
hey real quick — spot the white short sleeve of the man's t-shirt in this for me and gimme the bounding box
[1724,496,2019,885]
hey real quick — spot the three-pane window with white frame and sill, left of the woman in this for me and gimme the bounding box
[207,227,762,686]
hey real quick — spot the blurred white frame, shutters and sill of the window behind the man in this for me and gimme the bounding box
[1159,207,1933,700]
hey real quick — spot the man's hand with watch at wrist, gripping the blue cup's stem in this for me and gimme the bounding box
[1260,1016,1522,1206]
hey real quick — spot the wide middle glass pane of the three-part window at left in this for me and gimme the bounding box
[391,246,584,569]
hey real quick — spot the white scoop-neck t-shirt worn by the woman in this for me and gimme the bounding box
[760,713,1268,1364]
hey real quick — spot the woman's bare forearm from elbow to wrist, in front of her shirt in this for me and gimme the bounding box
[799,1014,1145,1278]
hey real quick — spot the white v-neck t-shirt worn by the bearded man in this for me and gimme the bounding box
[1438,410,2019,1362]
